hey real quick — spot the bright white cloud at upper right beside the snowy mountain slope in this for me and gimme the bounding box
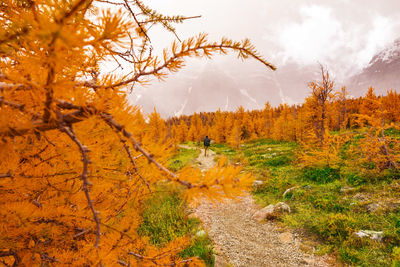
[275,2,400,78]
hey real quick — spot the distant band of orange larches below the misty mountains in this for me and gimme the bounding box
[166,87,400,149]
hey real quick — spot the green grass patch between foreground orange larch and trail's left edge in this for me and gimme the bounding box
[138,188,214,266]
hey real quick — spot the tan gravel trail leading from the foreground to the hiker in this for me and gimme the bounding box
[186,147,335,267]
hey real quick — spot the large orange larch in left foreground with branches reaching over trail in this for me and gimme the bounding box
[0,0,275,266]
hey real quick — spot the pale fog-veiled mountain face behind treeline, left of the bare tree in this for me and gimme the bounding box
[132,62,319,117]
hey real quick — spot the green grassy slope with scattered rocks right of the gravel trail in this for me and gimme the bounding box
[212,137,400,266]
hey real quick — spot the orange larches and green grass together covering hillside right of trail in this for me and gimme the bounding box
[167,67,400,266]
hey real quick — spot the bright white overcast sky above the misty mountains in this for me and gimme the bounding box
[146,0,400,77]
